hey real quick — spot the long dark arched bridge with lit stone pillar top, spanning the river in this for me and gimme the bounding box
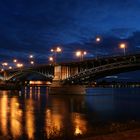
[1,54,140,85]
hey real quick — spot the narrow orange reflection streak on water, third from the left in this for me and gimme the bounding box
[25,99,35,139]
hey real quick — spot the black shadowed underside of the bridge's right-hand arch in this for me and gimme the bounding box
[62,65,140,84]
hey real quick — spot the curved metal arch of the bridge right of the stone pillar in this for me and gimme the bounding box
[62,59,140,84]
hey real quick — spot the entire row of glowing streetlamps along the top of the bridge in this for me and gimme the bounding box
[1,37,127,71]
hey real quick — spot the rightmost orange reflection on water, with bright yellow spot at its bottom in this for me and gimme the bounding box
[72,113,87,135]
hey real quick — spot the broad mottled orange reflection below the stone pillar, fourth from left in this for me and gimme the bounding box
[45,99,67,139]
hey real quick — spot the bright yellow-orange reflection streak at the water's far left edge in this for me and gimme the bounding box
[0,91,8,135]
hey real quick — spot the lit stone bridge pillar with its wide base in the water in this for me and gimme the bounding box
[49,66,85,95]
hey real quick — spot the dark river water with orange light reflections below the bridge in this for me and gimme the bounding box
[0,87,140,140]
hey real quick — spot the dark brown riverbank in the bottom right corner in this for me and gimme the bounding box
[75,120,140,140]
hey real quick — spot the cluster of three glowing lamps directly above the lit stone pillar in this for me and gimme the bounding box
[49,46,62,63]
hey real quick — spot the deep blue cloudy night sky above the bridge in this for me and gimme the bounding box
[0,0,140,80]
